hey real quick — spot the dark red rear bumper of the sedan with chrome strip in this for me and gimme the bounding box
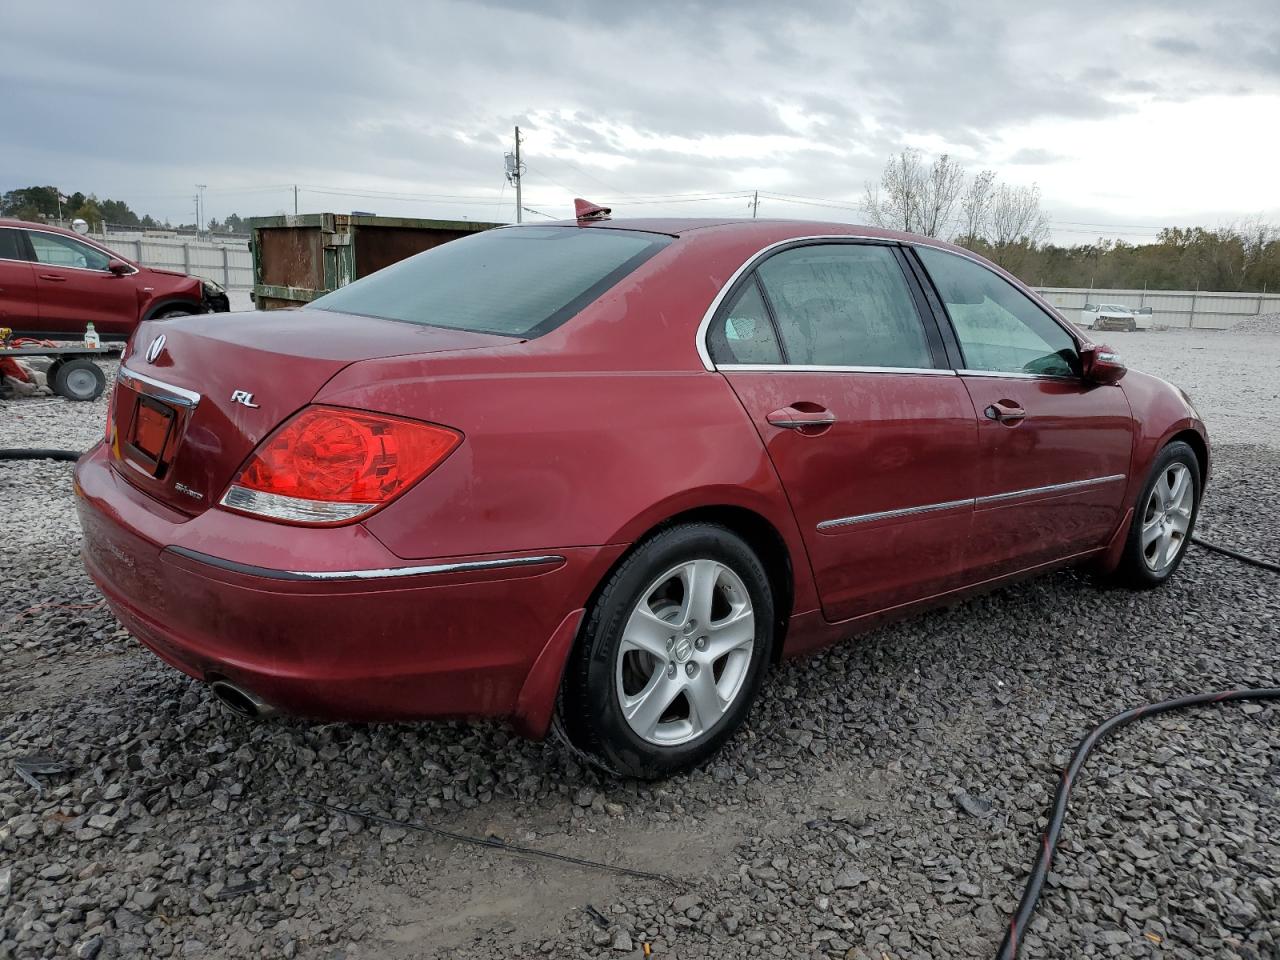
[76,447,622,735]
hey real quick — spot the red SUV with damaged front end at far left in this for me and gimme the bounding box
[0,220,230,340]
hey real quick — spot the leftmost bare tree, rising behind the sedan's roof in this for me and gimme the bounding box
[863,148,964,237]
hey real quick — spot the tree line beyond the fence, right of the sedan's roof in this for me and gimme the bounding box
[863,150,1280,293]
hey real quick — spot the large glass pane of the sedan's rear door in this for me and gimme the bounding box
[758,243,934,369]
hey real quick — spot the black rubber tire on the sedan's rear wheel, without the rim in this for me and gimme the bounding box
[557,524,774,780]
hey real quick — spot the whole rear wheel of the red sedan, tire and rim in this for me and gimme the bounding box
[559,524,774,780]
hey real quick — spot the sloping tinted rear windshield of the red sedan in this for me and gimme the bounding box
[311,227,671,338]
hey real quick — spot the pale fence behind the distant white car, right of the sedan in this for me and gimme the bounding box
[1033,287,1280,330]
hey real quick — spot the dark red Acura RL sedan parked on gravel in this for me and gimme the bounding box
[76,212,1208,777]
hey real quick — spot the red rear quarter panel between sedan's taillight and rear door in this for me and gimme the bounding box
[316,355,814,609]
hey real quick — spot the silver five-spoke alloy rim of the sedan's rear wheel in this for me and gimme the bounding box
[614,559,755,746]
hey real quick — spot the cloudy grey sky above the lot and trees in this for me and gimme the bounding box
[0,0,1280,242]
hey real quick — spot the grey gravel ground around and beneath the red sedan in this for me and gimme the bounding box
[0,333,1280,960]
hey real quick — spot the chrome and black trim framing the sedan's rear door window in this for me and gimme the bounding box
[695,239,955,376]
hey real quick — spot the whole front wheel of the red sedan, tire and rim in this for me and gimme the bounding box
[1116,440,1201,589]
